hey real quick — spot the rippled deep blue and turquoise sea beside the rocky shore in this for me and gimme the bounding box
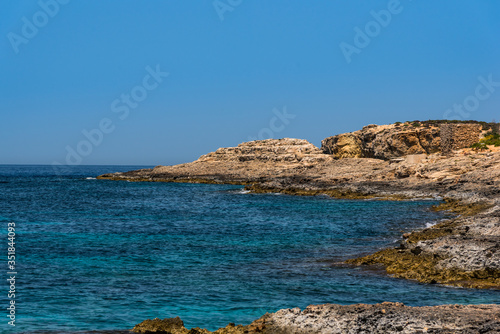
[0,165,500,333]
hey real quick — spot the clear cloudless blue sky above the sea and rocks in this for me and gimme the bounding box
[0,0,500,165]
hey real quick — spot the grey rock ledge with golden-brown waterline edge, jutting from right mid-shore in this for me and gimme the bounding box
[347,202,500,289]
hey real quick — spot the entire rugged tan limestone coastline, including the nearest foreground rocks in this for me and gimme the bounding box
[98,122,500,334]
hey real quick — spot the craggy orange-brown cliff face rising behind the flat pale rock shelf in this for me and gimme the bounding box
[321,123,441,160]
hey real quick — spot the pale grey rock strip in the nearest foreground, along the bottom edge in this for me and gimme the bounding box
[133,303,500,334]
